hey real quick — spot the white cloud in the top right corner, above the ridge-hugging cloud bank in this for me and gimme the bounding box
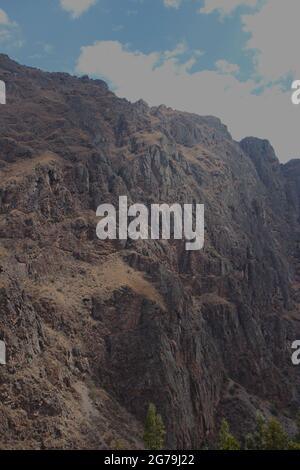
[242,0,300,81]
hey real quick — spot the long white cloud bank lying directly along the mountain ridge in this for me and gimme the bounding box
[77,41,300,161]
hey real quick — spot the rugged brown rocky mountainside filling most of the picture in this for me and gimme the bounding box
[0,55,300,449]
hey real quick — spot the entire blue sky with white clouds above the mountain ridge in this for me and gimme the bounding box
[0,0,300,162]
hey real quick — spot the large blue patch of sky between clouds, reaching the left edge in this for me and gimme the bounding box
[0,0,252,73]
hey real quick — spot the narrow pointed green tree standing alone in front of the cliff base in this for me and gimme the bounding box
[144,403,166,450]
